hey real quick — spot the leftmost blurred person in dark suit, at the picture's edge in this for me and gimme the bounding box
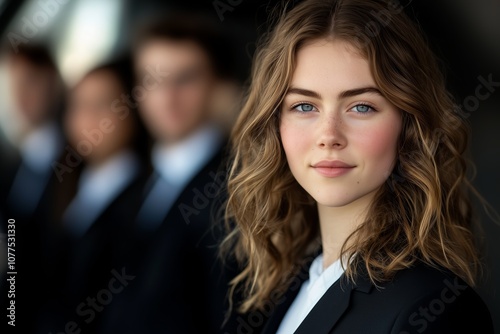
[0,43,65,329]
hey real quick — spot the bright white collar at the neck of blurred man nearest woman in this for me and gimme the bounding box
[152,125,222,187]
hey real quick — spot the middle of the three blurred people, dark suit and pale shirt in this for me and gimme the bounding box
[39,57,146,332]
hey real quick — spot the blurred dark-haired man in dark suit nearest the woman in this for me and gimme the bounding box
[104,15,238,334]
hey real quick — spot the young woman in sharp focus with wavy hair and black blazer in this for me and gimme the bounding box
[224,0,493,334]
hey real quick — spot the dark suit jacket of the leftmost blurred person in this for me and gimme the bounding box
[0,145,68,333]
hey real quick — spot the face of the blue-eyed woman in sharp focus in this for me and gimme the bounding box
[280,40,402,207]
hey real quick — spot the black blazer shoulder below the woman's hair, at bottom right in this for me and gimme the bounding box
[375,263,493,333]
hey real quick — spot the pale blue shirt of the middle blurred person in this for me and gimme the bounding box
[63,150,139,237]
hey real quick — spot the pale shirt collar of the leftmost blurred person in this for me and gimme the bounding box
[20,122,62,172]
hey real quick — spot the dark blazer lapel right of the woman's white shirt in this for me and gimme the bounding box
[295,263,372,334]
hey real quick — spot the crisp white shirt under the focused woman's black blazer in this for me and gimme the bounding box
[276,254,344,334]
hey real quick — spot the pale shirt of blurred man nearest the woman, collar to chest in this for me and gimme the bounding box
[137,124,222,230]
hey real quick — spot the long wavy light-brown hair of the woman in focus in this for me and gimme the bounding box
[223,0,480,312]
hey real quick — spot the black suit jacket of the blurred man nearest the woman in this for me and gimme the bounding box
[101,147,228,334]
